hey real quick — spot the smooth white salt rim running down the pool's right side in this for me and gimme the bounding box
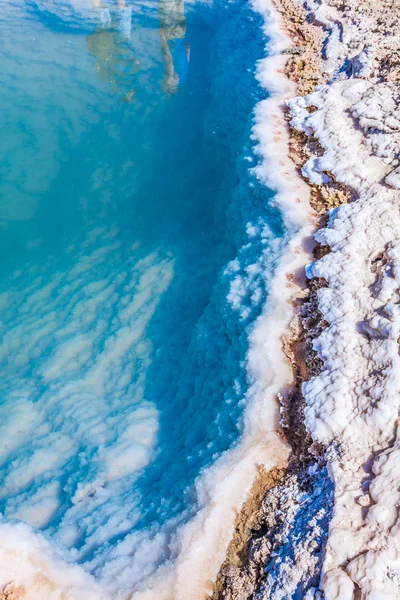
[117,0,315,600]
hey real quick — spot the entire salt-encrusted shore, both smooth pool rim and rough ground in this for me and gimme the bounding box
[0,0,400,600]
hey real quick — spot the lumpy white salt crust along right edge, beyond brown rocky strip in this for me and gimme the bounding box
[289,0,400,600]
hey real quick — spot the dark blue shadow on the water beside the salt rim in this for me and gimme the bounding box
[136,2,283,527]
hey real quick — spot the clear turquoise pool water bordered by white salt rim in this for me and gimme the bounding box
[0,0,284,590]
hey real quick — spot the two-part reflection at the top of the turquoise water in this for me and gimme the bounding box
[87,0,190,102]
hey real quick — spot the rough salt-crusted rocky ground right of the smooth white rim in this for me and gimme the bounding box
[214,0,400,600]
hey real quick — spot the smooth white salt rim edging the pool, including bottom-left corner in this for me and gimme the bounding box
[0,5,313,600]
